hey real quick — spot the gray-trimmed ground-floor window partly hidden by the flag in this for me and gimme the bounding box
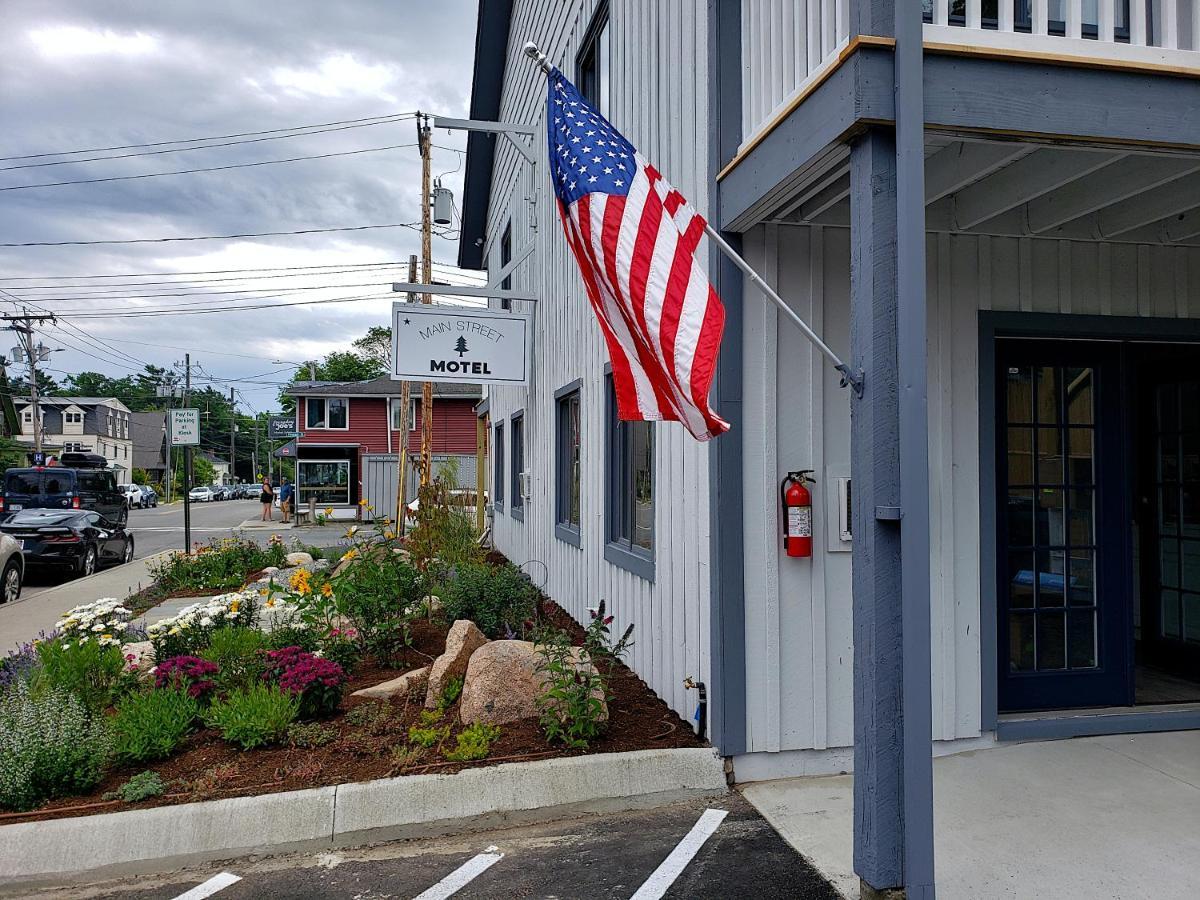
[605,374,654,578]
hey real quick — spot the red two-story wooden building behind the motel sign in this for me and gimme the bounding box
[288,376,482,515]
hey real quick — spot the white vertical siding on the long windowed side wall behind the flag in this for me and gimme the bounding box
[485,0,709,718]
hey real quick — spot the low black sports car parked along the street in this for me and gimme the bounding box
[0,509,133,575]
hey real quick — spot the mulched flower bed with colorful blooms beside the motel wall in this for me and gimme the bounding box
[0,482,701,823]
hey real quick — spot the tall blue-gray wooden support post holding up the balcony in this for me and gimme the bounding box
[851,0,934,899]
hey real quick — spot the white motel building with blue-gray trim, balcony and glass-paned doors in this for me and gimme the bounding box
[460,0,1200,825]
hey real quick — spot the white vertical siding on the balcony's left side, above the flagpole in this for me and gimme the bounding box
[742,0,850,143]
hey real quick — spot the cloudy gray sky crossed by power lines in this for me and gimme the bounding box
[0,0,476,412]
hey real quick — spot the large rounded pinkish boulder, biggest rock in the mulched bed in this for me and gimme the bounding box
[458,641,608,725]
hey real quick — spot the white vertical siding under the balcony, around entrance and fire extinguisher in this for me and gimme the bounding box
[744,226,1200,751]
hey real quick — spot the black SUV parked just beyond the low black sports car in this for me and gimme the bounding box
[0,454,130,524]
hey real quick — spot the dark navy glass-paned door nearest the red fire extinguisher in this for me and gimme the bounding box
[996,340,1133,712]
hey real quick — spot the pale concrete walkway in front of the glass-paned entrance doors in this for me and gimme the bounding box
[743,731,1200,900]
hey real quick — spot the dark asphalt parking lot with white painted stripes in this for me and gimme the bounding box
[44,794,838,900]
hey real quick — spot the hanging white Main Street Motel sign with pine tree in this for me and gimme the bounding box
[391,302,529,384]
